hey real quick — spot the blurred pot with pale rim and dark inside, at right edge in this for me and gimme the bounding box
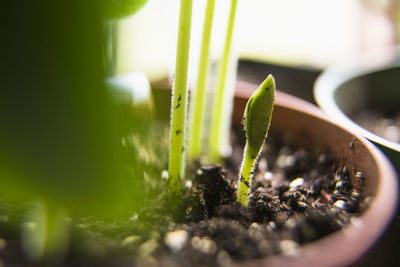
[314,47,400,173]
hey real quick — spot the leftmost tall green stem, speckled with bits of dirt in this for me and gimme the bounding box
[168,0,193,194]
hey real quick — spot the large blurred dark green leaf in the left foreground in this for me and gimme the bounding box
[0,0,130,217]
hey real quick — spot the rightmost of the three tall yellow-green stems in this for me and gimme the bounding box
[209,0,238,162]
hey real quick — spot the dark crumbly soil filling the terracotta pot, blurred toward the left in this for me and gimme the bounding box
[0,132,371,267]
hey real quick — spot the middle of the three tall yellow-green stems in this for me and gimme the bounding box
[189,0,215,158]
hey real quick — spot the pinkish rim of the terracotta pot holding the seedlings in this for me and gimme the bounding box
[235,82,397,267]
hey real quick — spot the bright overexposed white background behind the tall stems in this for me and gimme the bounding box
[117,0,400,90]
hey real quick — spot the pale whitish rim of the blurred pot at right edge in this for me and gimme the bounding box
[314,46,400,152]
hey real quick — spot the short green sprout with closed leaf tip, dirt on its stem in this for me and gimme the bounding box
[237,75,275,206]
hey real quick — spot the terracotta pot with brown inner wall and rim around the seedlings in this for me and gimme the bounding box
[233,82,397,267]
